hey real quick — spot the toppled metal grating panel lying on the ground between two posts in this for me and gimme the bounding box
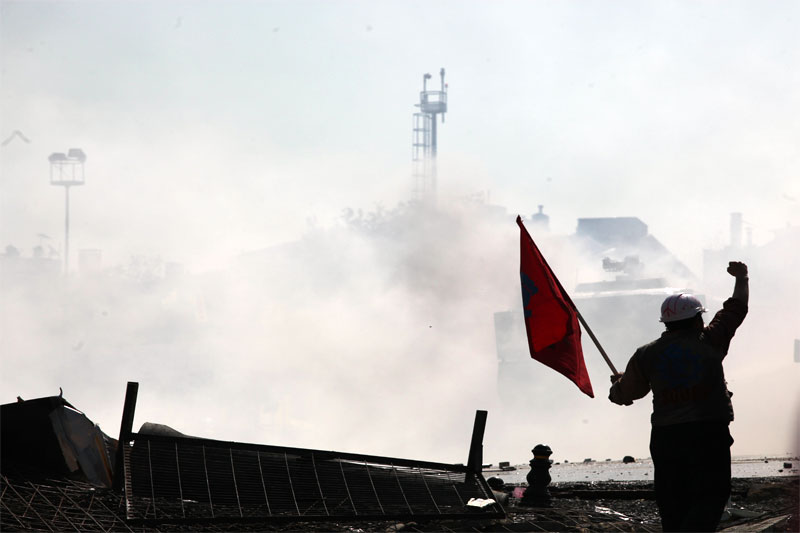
[123,434,504,522]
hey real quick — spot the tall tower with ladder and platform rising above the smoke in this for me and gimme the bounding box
[411,68,447,202]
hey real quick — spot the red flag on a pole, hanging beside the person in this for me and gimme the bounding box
[517,216,594,398]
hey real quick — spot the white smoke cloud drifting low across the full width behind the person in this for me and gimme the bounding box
[2,197,798,462]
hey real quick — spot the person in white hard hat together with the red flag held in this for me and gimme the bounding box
[517,216,749,531]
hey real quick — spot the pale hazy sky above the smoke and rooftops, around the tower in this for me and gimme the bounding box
[0,0,800,460]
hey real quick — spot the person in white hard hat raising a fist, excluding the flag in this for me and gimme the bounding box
[609,261,749,531]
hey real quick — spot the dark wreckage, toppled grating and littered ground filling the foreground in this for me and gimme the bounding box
[0,386,800,533]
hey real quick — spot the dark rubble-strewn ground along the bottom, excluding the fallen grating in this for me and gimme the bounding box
[0,476,800,533]
